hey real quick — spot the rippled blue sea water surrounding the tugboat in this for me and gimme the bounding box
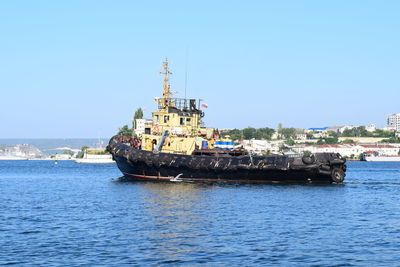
[0,161,400,266]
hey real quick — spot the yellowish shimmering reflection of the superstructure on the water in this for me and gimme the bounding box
[143,183,207,262]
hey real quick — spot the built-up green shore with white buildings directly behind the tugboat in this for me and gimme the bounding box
[132,113,400,159]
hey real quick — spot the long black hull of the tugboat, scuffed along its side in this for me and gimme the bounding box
[108,136,346,184]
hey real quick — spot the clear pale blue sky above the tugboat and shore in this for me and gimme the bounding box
[0,0,400,138]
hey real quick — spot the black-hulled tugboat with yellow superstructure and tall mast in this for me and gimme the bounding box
[107,59,346,184]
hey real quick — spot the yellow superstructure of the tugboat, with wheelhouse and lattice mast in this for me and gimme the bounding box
[142,59,214,154]
